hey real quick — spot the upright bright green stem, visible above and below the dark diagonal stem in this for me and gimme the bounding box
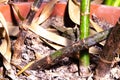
[80,0,90,66]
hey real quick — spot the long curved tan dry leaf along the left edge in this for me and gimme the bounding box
[0,13,11,62]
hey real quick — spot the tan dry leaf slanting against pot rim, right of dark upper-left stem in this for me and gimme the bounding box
[37,0,58,24]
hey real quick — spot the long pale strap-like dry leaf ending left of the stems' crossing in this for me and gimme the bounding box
[29,24,72,46]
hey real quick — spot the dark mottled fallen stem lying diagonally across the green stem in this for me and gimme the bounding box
[30,28,112,69]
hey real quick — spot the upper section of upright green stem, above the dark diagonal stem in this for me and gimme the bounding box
[80,0,90,39]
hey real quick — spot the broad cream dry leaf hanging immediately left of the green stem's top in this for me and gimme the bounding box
[68,0,80,25]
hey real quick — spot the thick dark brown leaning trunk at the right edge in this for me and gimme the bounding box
[96,24,120,77]
